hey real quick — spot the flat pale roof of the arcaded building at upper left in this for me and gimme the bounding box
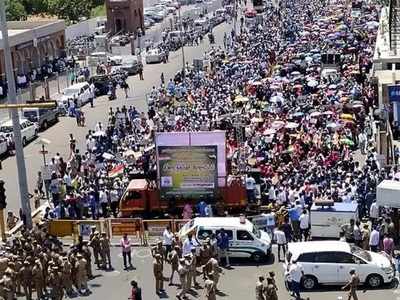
[0,20,65,49]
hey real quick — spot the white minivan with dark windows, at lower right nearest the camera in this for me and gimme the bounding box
[283,241,395,290]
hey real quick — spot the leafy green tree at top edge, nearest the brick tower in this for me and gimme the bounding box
[48,0,92,22]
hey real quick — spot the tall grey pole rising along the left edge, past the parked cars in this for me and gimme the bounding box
[0,0,32,229]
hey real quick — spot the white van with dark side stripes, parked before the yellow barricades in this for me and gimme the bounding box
[179,217,271,262]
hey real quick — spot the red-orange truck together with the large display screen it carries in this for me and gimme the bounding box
[120,131,247,217]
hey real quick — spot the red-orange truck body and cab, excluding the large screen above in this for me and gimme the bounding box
[119,179,247,217]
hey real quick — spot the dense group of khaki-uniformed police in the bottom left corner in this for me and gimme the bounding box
[0,222,111,300]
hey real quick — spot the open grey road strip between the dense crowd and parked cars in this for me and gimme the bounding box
[0,15,231,212]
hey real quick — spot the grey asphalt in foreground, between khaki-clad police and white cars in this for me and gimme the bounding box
[25,248,400,300]
